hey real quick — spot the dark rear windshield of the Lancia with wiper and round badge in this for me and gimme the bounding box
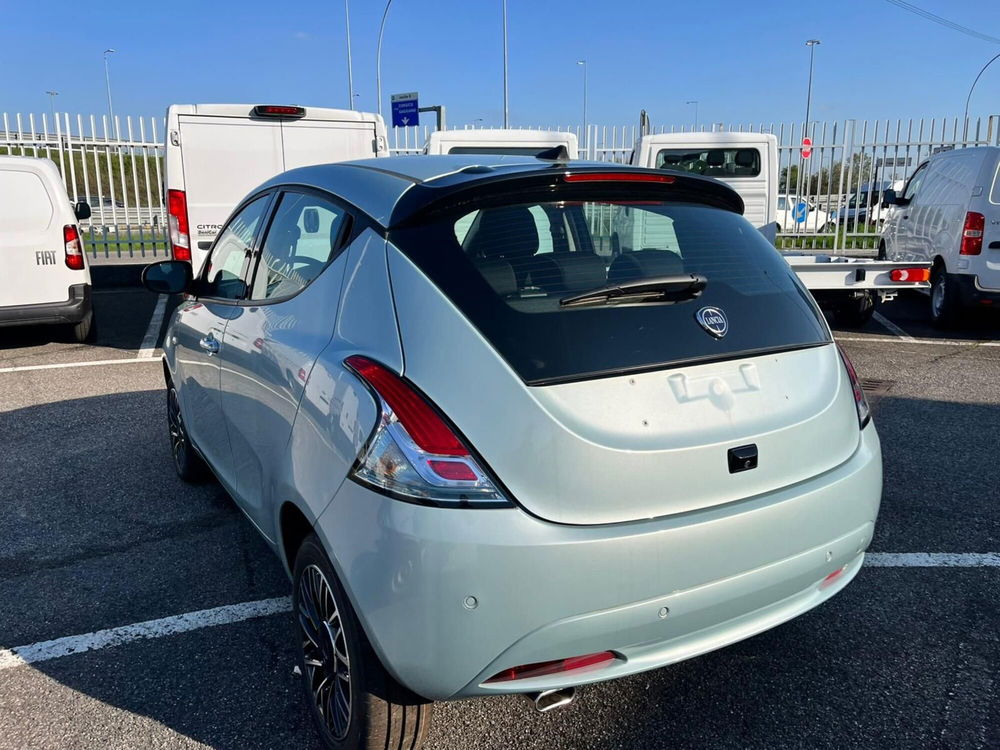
[389,188,830,385]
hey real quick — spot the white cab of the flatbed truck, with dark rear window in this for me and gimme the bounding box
[632,131,778,232]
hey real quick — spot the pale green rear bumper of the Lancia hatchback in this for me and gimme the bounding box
[317,426,882,700]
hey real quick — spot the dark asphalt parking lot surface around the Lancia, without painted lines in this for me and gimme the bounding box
[0,289,1000,750]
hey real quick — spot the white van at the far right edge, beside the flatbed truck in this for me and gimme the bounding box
[880,146,1000,326]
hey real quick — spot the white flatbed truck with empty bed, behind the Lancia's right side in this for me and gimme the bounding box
[622,131,930,326]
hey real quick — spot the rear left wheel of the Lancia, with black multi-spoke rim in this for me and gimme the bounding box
[292,534,432,750]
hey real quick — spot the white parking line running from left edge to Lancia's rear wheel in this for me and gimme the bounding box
[0,596,292,671]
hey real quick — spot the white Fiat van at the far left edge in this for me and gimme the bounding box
[0,156,95,342]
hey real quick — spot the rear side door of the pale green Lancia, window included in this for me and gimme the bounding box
[221,189,354,538]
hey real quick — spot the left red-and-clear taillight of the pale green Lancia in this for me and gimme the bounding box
[344,356,511,507]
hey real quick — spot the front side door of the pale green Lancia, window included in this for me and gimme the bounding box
[170,195,271,488]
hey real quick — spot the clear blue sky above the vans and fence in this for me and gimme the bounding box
[0,0,1000,126]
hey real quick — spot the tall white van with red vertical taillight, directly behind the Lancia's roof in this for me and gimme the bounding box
[164,104,389,270]
